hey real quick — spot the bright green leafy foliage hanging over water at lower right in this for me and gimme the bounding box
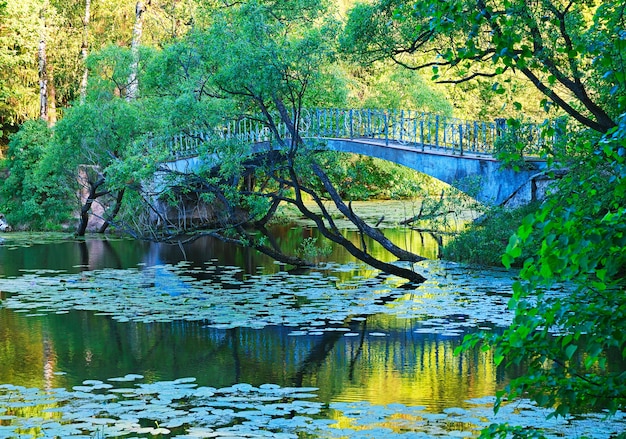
[454,116,626,430]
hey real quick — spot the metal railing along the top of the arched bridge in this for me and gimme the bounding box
[163,108,545,158]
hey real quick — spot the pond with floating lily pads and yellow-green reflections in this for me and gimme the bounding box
[0,211,626,438]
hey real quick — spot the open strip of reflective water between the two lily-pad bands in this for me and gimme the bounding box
[0,309,502,411]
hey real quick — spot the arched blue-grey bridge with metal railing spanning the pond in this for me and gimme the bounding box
[160,109,554,204]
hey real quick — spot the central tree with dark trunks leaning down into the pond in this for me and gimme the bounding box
[129,0,423,281]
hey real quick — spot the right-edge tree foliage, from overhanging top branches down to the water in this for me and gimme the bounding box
[344,0,626,437]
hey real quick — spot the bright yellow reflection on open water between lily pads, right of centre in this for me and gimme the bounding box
[300,316,502,411]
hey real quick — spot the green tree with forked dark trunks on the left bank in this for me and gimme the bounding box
[47,42,161,236]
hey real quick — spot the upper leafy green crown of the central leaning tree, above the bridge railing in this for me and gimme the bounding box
[193,0,337,112]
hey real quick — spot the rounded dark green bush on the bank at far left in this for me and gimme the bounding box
[0,121,74,229]
